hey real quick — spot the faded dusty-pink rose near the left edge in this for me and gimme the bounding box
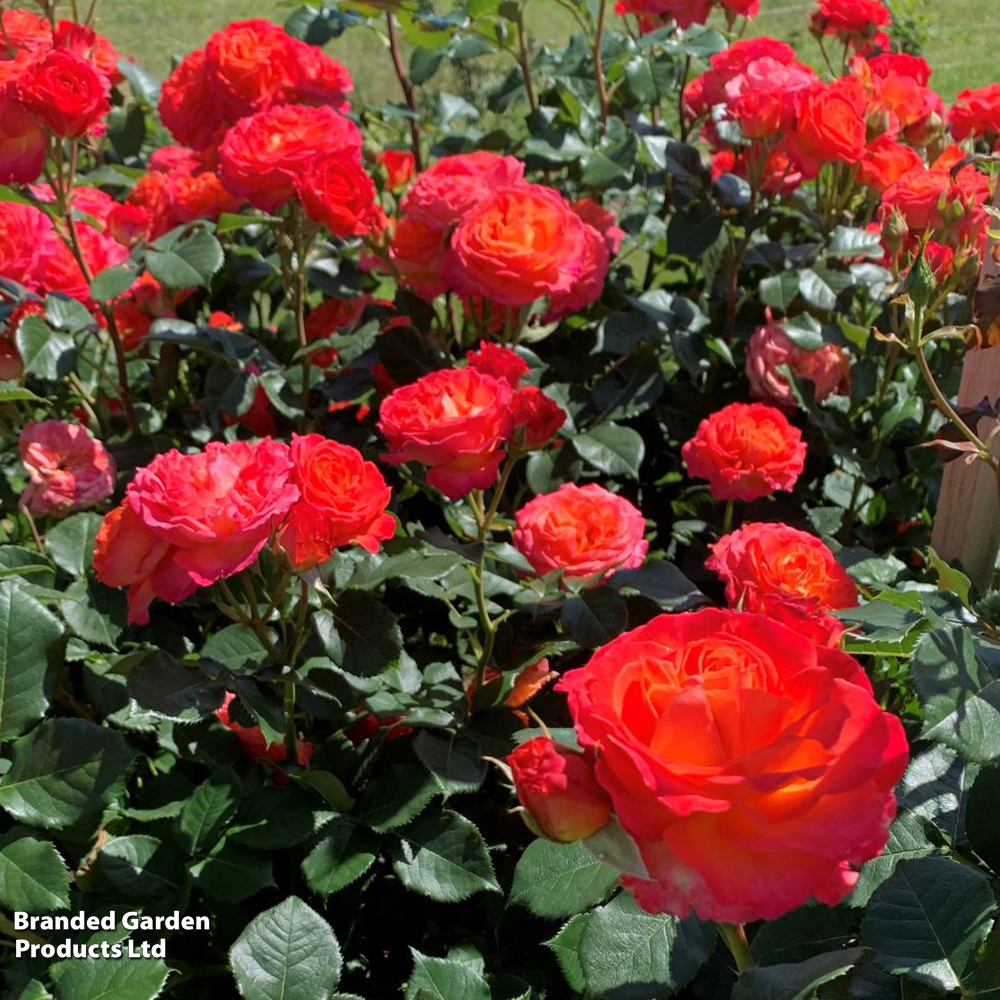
[21,420,115,517]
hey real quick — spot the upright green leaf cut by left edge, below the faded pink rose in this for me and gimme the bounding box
[0,580,62,741]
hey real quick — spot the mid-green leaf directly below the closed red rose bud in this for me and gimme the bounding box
[508,840,619,917]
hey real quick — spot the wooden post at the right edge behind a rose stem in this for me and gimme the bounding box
[931,185,1000,593]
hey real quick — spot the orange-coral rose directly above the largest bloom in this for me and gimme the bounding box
[705,523,858,611]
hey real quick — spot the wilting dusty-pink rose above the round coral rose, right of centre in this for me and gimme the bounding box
[746,317,850,409]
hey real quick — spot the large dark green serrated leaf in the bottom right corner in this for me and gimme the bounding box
[861,857,996,990]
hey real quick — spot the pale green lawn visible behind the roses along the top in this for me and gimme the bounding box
[98,0,1000,102]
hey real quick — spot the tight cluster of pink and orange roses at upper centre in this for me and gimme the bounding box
[378,151,624,320]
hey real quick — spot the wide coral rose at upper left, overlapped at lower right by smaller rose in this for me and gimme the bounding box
[219,104,362,212]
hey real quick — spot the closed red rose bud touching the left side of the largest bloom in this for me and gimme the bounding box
[507,736,611,843]
